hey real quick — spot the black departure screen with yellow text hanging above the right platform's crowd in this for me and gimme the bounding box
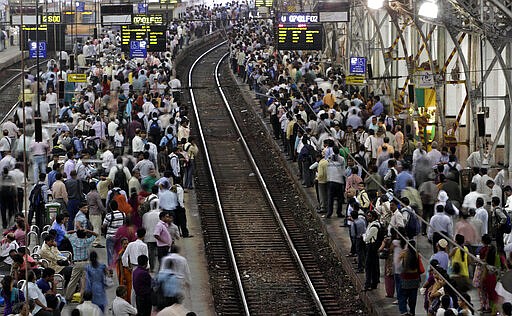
[277,23,323,50]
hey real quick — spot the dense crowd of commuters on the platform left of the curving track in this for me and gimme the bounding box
[0,4,254,316]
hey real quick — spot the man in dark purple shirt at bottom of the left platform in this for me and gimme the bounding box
[133,255,152,316]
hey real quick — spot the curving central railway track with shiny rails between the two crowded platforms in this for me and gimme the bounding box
[188,40,362,315]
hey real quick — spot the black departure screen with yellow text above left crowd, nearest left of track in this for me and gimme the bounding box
[121,25,166,52]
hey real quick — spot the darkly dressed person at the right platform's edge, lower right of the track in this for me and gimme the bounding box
[363,211,380,291]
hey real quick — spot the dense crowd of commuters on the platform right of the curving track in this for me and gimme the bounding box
[230,16,512,315]
